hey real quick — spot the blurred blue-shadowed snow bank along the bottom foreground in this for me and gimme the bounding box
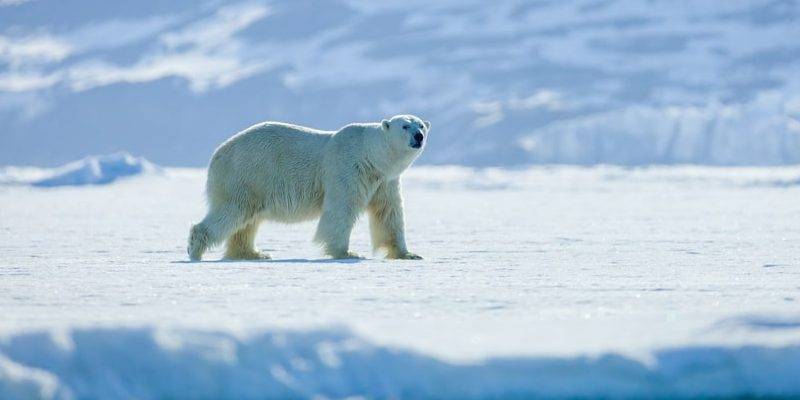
[0,328,800,399]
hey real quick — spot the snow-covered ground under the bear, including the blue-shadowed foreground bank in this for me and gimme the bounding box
[0,167,800,398]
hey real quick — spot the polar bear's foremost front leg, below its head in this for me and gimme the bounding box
[367,179,422,260]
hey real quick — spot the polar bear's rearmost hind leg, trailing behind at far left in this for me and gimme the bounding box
[187,204,245,261]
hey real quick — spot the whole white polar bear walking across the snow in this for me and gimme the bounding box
[188,115,431,261]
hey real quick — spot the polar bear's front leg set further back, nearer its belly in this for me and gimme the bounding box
[314,182,364,258]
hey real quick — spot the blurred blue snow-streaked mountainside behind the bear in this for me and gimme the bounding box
[0,0,800,166]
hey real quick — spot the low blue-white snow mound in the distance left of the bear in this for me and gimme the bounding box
[0,152,160,187]
